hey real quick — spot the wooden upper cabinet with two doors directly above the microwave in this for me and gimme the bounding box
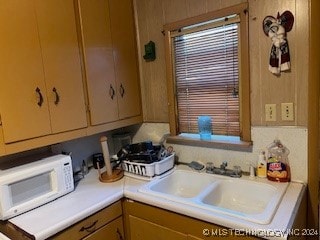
[0,0,87,143]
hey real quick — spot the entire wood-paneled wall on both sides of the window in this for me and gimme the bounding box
[134,0,309,126]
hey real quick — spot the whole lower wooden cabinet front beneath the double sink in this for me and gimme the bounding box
[124,199,260,240]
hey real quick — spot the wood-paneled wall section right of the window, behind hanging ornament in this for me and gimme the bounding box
[249,0,309,126]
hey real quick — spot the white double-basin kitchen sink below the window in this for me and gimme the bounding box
[139,170,288,224]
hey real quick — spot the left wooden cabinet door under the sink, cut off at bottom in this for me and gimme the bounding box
[129,216,187,240]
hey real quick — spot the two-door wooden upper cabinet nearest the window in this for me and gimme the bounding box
[78,0,141,125]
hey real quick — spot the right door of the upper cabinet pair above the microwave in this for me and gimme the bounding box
[35,0,87,133]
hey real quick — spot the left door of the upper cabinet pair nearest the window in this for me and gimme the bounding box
[78,0,118,125]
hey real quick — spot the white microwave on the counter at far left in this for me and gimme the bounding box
[0,155,74,220]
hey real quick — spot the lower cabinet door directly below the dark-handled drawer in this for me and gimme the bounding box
[84,217,125,240]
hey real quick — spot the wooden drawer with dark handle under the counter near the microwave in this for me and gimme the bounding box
[51,201,122,240]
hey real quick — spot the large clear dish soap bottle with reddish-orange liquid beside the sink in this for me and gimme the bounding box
[267,139,291,182]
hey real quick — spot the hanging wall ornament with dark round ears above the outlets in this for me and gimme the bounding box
[262,11,294,75]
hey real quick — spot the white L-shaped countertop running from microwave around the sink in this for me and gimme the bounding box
[5,166,305,240]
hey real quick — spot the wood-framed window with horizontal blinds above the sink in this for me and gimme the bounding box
[165,3,250,148]
